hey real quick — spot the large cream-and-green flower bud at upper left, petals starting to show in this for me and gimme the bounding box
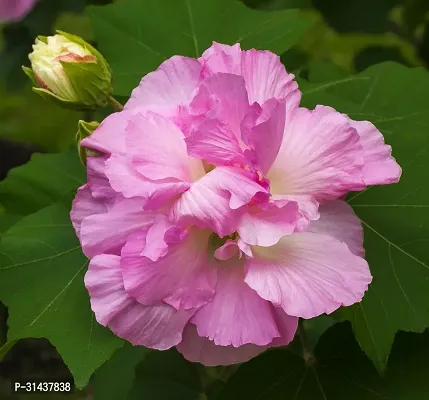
[23,31,112,109]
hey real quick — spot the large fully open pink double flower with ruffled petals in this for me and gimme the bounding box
[71,43,401,365]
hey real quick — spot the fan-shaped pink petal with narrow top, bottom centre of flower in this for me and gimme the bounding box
[191,259,280,347]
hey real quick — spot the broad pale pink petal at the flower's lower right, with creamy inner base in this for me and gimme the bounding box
[245,232,372,318]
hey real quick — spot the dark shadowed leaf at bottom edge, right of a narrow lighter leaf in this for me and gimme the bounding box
[127,350,202,400]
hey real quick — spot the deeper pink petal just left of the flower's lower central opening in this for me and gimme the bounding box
[121,228,216,309]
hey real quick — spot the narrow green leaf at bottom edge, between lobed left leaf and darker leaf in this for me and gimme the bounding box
[92,342,151,400]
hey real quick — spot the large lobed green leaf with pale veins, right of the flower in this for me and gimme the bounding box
[302,63,429,371]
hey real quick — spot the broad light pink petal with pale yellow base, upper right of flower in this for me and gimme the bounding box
[267,106,365,201]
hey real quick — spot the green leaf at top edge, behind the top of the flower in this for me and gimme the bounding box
[88,0,309,95]
